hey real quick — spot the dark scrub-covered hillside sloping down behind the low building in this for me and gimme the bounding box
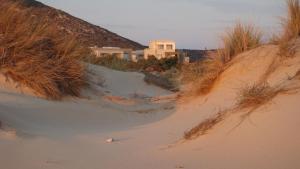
[0,0,144,49]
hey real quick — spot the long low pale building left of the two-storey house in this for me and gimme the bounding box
[91,47,132,60]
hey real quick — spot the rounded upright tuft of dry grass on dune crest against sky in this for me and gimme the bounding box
[219,22,262,63]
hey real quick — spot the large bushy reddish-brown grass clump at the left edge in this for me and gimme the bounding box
[0,2,86,100]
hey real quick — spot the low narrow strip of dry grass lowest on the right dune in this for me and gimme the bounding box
[184,111,227,140]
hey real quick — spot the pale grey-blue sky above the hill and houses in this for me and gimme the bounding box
[40,0,285,49]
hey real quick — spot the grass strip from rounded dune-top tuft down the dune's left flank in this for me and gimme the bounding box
[182,23,262,95]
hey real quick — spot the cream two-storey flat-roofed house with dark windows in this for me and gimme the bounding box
[144,40,176,59]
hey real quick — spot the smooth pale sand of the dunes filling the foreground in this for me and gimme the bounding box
[0,46,300,169]
